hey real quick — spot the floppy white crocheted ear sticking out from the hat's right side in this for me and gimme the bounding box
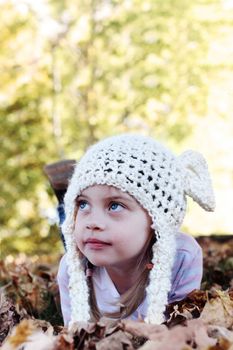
[178,150,215,211]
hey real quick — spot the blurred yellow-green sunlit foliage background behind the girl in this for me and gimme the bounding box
[0,0,233,260]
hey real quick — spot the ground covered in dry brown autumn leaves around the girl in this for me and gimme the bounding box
[0,236,233,350]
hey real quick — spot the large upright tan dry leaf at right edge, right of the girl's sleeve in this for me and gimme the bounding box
[200,291,233,329]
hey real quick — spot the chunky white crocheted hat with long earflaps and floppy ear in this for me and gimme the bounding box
[62,134,215,324]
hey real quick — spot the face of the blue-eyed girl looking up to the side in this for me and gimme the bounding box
[74,185,151,269]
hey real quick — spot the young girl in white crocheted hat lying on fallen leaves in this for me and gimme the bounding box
[58,134,215,326]
